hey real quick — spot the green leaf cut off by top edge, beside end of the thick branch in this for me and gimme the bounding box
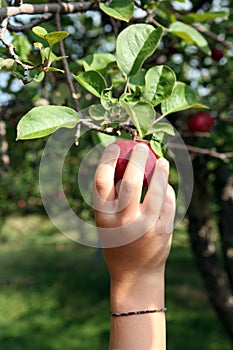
[99,0,134,22]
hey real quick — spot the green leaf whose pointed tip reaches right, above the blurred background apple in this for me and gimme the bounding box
[161,82,208,116]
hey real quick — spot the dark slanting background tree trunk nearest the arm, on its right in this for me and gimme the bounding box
[188,156,233,343]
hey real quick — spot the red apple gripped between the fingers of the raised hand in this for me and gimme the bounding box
[114,140,158,188]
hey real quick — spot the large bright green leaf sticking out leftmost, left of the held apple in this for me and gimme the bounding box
[16,106,79,140]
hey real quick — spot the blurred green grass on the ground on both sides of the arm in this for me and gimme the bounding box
[0,216,232,350]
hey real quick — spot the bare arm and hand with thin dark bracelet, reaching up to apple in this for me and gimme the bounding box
[94,144,175,350]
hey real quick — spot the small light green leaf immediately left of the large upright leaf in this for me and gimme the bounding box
[79,53,116,71]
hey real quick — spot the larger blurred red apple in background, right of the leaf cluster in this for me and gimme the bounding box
[187,112,214,132]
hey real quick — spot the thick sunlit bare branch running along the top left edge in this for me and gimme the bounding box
[0,1,93,18]
